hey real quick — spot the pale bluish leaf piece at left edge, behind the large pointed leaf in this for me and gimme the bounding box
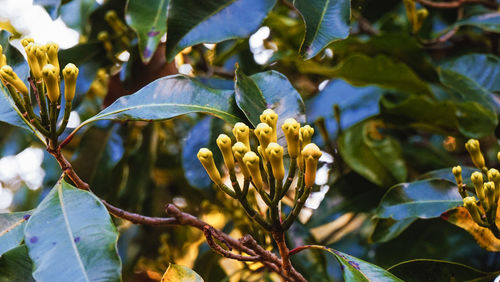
[0,211,32,255]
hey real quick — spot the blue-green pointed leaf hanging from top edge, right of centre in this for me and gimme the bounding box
[293,0,351,59]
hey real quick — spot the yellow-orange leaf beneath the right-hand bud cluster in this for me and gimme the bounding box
[441,207,500,252]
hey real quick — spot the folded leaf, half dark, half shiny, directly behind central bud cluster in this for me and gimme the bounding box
[235,70,305,130]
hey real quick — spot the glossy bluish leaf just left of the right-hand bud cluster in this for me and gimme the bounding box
[376,179,463,220]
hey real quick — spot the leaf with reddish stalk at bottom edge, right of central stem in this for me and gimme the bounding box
[296,245,403,281]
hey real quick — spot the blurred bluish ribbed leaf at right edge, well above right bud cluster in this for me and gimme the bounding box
[441,54,500,91]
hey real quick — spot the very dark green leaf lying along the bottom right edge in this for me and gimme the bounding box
[388,259,500,282]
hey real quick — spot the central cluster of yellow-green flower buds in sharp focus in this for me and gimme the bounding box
[198,109,321,229]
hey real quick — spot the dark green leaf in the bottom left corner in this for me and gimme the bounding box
[0,245,35,282]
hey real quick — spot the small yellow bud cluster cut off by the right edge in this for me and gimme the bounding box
[452,139,500,233]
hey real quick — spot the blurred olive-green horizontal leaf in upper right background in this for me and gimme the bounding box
[297,54,431,94]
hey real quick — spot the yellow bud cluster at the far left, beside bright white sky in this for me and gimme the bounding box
[0,38,78,146]
